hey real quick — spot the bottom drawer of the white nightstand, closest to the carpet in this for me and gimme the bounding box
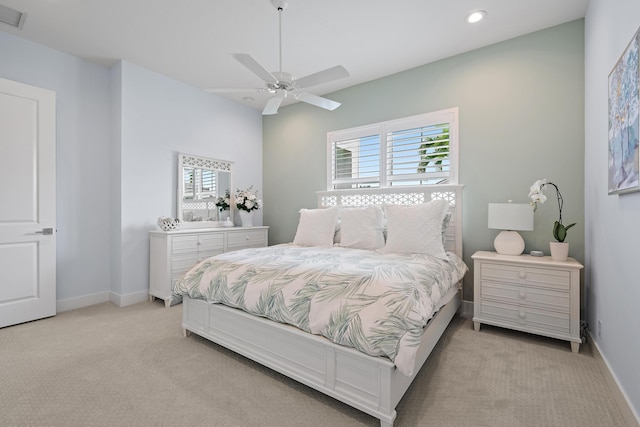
[480,301,571,335]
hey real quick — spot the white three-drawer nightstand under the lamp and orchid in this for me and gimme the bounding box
[471,251,582,353]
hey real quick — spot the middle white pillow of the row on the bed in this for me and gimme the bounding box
[340,206,384,250]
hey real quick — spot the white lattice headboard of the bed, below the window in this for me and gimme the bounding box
[316,184,464,257]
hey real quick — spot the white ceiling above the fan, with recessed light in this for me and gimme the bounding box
[0,0,589,110]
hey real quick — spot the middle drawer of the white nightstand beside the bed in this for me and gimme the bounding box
[480,281,571,312]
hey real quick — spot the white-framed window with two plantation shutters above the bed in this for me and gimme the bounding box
[327,108,458,190]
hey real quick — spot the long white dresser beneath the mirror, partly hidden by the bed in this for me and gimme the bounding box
[149,226,269,307]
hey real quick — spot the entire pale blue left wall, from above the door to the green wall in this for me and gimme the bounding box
[0,32,262,310]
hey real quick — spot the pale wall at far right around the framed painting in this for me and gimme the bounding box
[585,0,640,422]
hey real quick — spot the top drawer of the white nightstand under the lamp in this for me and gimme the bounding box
[480,262,571,292]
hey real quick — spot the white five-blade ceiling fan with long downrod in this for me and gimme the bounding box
[208,0,349,115]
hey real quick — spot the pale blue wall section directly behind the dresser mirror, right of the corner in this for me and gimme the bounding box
[112,62,262,304]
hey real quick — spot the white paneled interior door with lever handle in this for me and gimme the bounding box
[0,79,56,328]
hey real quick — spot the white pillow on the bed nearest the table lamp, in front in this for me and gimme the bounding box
[384,200,449,258]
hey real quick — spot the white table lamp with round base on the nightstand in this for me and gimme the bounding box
[489,201,533,255]
